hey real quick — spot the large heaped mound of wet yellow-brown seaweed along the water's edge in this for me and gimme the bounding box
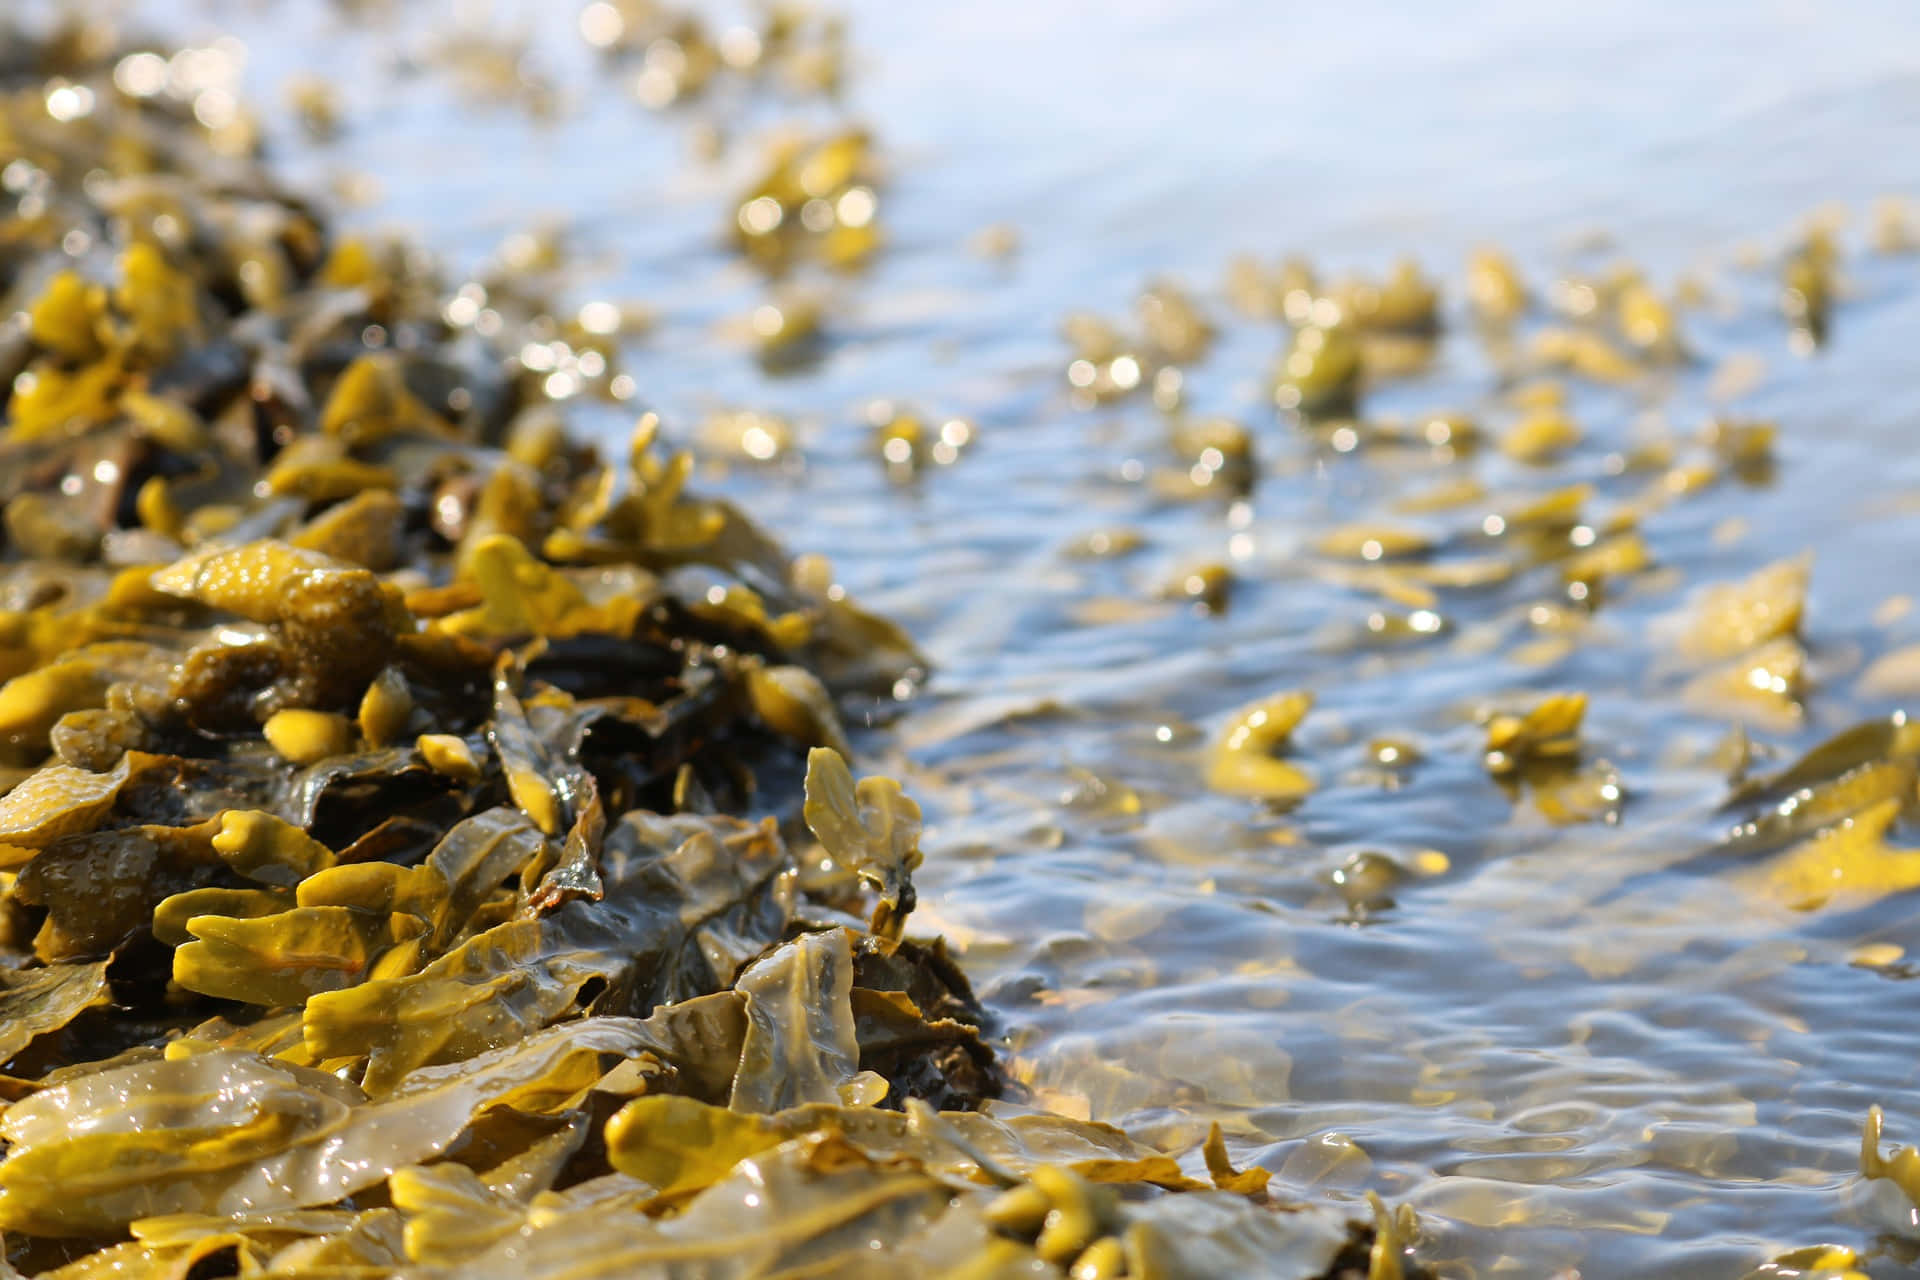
[0,20,1405,1278]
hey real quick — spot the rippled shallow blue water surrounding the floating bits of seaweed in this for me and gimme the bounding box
[97,0,1920,1276]
